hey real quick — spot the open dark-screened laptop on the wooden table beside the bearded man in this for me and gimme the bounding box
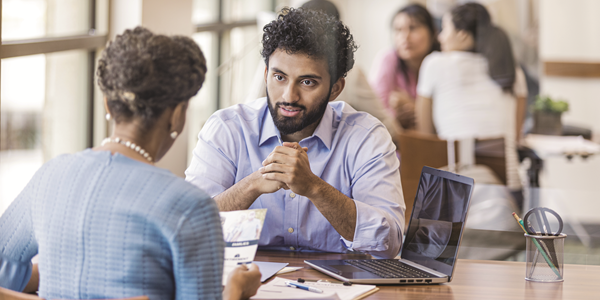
[304,167,474,284]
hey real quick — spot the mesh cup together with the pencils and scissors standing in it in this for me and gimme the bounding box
[513,207,567,282]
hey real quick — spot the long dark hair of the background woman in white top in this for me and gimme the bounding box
[451,3,515,93]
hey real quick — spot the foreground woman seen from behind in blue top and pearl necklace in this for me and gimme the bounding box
[0,27,260,299]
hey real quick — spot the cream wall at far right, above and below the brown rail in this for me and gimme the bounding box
[539,0,600,142]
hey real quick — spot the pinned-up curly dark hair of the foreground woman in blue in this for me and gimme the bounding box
[96,27,206,129]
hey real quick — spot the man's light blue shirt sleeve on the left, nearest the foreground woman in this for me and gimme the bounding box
[185,114,240,197]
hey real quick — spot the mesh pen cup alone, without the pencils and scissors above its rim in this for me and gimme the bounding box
[525,233,567,282]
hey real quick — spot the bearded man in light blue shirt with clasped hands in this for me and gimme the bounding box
[186,8,406,258]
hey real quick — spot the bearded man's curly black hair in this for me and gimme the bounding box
[261,8,357,84]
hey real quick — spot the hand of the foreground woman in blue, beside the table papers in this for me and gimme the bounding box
[223,264,260,300]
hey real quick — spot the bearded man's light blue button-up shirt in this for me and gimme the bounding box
[186,98,406,257]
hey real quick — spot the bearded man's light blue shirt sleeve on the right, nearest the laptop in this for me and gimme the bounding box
[342,124,406,258]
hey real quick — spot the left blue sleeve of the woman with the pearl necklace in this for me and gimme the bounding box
[0,173,38,292]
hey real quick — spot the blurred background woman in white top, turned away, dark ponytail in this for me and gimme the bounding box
[416,3,527,190]
